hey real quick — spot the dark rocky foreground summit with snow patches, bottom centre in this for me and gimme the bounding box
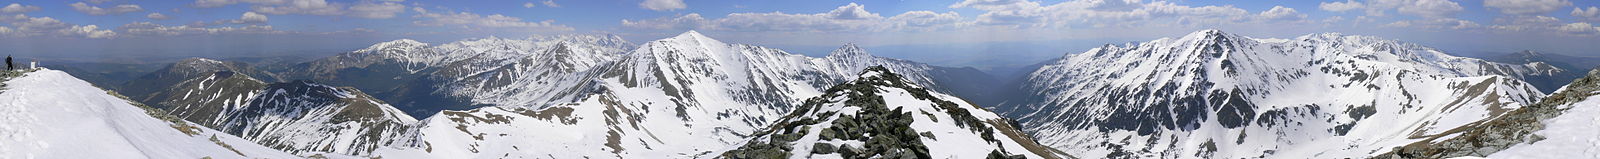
[720,67,1061,159]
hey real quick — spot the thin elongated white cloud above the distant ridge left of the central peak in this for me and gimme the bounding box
[411,8,574,31]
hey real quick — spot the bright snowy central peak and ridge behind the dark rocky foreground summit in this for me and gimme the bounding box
[379,31,960,157]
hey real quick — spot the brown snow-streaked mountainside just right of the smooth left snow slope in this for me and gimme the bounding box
[131,61,416,154]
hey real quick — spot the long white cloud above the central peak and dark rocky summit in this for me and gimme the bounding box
[622,3,962,32]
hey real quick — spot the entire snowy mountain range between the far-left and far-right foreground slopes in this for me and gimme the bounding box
[84,31,1590,159]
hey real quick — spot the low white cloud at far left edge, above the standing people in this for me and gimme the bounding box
[0,14,117,39]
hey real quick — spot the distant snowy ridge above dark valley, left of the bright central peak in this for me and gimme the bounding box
[288,35,634,116]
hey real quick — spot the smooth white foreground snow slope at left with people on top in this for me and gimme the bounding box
[0,69,298,159]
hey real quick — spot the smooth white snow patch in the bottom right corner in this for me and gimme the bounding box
[1488,96,1600,159]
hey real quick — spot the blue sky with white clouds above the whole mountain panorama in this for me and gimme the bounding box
[0,0,1600,67]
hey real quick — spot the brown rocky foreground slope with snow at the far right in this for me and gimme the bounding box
[1373,71,1600,159]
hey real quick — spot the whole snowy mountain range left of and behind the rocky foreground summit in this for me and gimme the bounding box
[118,32,1030,157]
